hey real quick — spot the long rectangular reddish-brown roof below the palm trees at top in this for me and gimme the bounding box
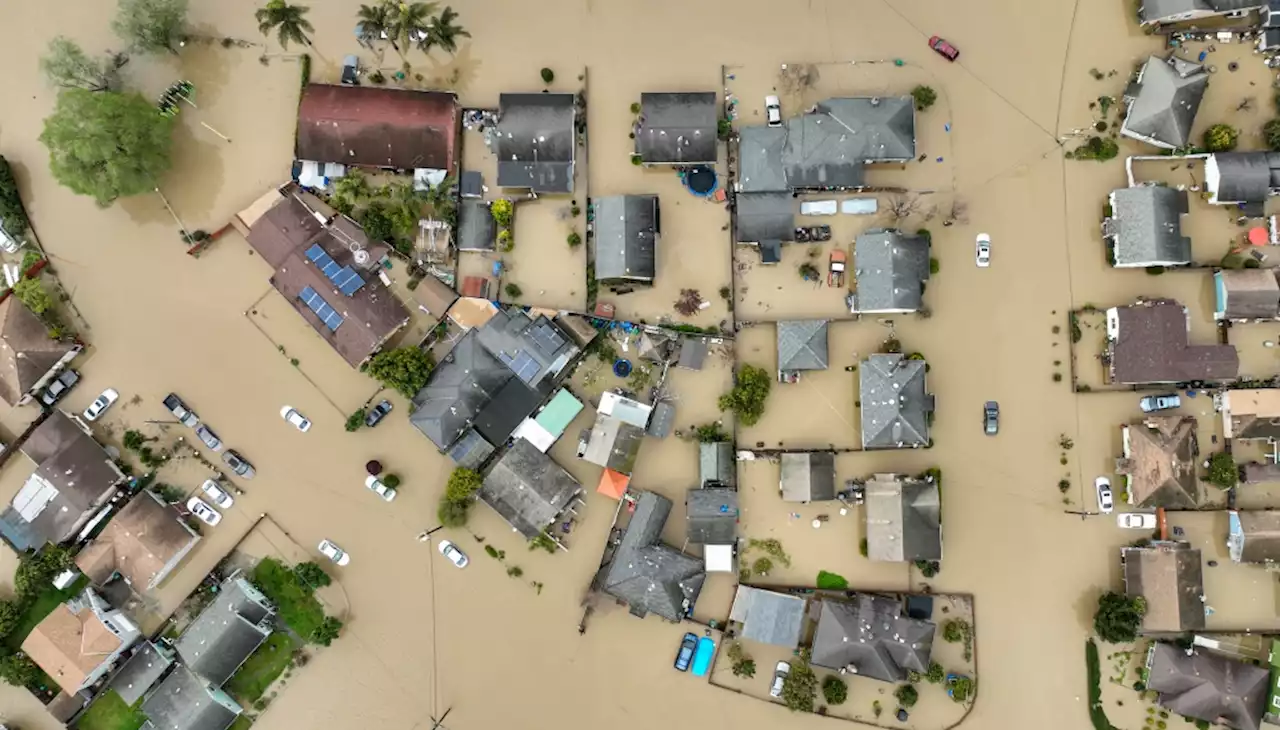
[297,83,460,170]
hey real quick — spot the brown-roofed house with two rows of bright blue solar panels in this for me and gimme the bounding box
[239,184,408,368]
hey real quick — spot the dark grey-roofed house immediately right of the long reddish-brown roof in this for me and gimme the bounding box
[497,93,577,193]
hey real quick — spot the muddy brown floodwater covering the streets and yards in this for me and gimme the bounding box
[0,0,1276,730]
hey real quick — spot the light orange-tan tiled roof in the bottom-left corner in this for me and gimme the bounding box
[22,603,120,693]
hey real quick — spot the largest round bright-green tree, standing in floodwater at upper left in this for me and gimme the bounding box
[40,88,173,207]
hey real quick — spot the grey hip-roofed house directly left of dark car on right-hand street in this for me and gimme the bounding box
[858,353,933,448]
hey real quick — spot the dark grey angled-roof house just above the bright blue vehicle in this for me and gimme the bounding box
[596,492,707,622]
